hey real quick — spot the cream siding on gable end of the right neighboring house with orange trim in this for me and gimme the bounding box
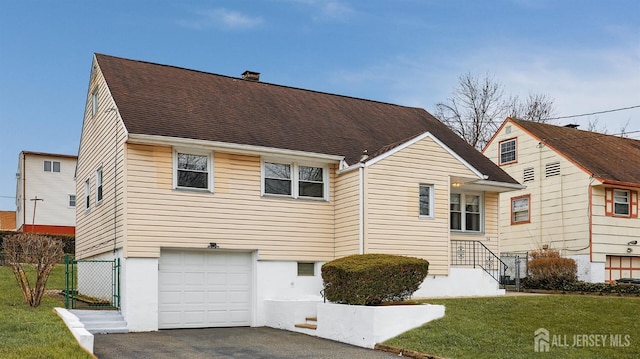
[485,125,589,255]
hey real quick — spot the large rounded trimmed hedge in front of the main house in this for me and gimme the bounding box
[322,254,429,305]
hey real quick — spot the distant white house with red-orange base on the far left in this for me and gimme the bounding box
[16,151,78,235]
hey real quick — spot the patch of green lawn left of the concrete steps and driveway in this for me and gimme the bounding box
[0,265,92,359]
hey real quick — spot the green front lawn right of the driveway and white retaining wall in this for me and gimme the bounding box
[385,295,640,359]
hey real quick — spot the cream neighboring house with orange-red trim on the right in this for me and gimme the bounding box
[483,118,640,282]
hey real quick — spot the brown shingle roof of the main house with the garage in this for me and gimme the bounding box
[96,54,517,183]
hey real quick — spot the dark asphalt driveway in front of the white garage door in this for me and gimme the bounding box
[94,327,396,359]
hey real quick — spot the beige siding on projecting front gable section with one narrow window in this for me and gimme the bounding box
[365,138,474,275]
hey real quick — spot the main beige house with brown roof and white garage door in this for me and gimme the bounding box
[76,54,522,331]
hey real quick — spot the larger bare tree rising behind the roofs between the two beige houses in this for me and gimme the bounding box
[435,73,507,149]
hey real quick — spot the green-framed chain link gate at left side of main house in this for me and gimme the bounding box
[65,255,120,309]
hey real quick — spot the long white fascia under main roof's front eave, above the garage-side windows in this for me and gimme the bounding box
[128,133,344,163]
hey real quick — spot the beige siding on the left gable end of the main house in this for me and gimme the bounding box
[76,62,126,258]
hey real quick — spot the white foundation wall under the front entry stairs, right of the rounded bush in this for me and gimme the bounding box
[412,267,505,298]
